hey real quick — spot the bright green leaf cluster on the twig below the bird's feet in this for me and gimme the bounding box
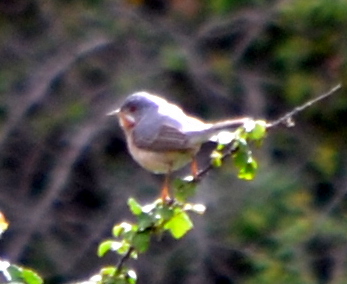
[98,198,205,284]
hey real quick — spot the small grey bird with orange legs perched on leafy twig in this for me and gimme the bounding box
[108,91,249,201]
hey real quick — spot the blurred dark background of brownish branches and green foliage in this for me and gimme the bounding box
[0,0,347,284]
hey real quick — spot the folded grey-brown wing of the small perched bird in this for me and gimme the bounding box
[133,117,192,151]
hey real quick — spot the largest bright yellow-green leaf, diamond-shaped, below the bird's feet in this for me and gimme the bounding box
[164,208,193,239]
